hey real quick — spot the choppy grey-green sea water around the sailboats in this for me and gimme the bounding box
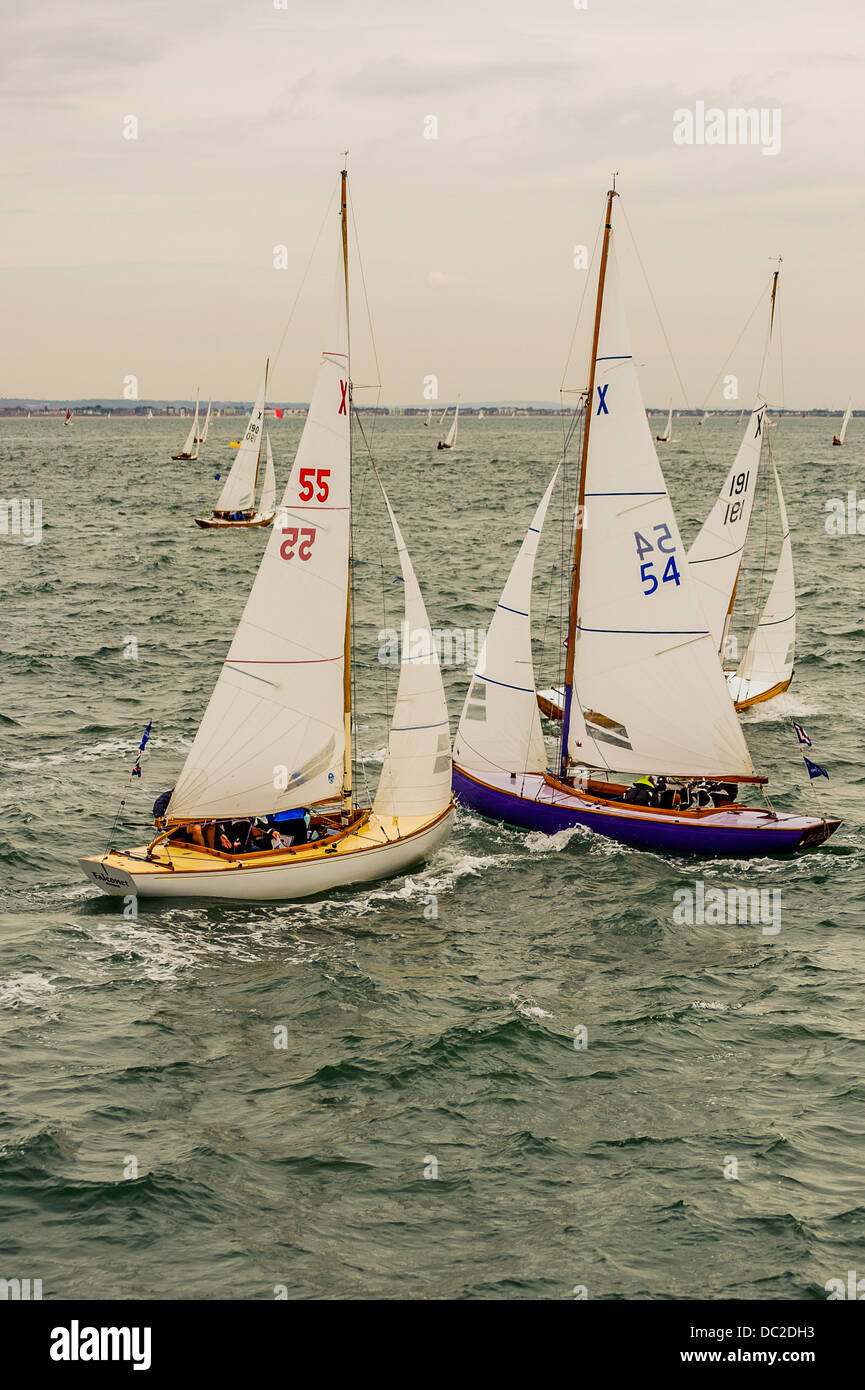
[0,417,865,1300]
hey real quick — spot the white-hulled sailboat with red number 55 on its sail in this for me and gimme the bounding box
[81,170,453,902]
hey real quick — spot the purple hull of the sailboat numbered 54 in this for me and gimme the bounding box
[453,765,840,858]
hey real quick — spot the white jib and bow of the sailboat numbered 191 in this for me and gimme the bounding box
[729,459,795,702]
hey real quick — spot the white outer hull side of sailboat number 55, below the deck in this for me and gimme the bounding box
[78,806,453,902]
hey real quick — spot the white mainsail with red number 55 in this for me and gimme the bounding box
[167,253,350,820]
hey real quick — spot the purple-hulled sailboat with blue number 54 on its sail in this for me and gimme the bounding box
[453,188,839,856]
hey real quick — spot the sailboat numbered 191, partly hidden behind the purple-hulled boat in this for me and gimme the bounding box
[688,270,795,709]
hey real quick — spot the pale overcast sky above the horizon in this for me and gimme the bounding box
[0,0,865,407]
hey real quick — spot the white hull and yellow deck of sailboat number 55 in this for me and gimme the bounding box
[78,803,453,902]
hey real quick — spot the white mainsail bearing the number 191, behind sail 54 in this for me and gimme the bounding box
[688,382,766,652]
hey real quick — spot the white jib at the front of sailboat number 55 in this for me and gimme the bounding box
[373,489,451,817]
